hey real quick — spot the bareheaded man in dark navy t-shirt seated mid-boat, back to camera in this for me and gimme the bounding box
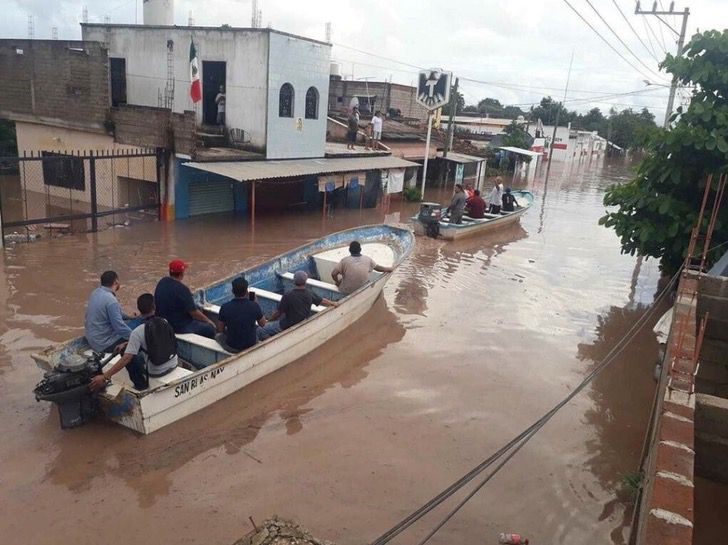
[215,278,266,352]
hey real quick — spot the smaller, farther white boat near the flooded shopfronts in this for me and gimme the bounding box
[412,190,533,240]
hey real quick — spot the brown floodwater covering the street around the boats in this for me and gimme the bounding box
[0,157,659,545]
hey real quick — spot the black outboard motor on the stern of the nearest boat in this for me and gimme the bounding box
[33,352,114,430]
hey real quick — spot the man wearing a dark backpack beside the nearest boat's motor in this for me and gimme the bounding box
[89,293,178,391]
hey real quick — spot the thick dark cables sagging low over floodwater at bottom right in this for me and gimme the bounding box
[371,267,682,545]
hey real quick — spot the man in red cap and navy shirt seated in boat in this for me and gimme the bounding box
[154,259,215,339]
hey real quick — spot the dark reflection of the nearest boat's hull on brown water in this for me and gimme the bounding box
[46,297,405,507]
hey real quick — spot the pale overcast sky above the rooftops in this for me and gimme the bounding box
[0,0,728,120]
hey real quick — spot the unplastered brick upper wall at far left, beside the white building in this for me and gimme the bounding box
[0,39,109,131]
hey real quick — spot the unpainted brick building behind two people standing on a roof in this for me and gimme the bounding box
[328,71,427,121]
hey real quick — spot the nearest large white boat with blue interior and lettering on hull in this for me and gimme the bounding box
[33,225,414,434]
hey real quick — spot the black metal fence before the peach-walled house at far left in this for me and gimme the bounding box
[0,149,162,236]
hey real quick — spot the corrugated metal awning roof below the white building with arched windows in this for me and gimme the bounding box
[184,155,420,182]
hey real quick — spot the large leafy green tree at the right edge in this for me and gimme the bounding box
[599,30,728,274]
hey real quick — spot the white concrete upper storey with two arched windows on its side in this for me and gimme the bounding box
[82,24,331,159]
